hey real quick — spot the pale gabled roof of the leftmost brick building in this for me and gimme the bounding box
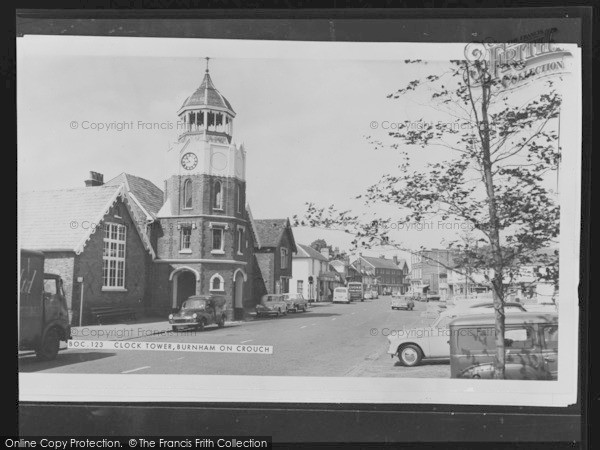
[18,184,154,256]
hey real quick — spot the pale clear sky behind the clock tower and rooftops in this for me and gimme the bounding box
[17,38,572,261]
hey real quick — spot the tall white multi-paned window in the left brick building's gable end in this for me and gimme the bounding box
[102,223,125,289]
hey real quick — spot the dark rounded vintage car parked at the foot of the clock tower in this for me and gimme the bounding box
[169,295,227,331]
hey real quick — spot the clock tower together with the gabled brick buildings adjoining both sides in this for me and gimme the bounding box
[20,62,296,323]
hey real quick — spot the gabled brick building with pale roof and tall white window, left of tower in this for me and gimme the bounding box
[19,180,154,325]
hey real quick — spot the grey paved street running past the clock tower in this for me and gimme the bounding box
[19,296,450,378]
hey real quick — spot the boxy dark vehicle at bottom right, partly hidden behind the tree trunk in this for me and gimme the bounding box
[449,312,558,380]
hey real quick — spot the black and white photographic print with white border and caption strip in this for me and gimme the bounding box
[17,28,582,406]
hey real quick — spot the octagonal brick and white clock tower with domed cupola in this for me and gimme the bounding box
[155,58,253,316]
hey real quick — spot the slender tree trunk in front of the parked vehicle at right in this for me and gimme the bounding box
[480,81,506,379]
